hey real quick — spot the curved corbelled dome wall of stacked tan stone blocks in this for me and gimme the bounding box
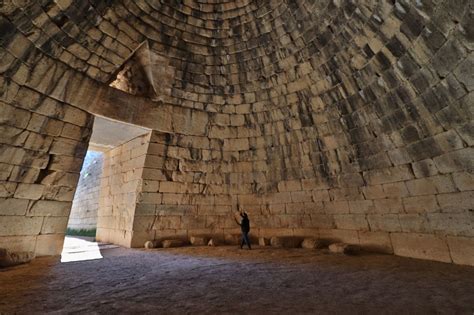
[0,0,474,265]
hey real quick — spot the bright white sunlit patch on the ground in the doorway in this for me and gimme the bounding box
[61,236,117,262]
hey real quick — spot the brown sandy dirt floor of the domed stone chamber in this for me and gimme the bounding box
[0,242,474,315]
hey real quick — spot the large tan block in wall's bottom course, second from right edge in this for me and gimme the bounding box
[390,233,452,263]
